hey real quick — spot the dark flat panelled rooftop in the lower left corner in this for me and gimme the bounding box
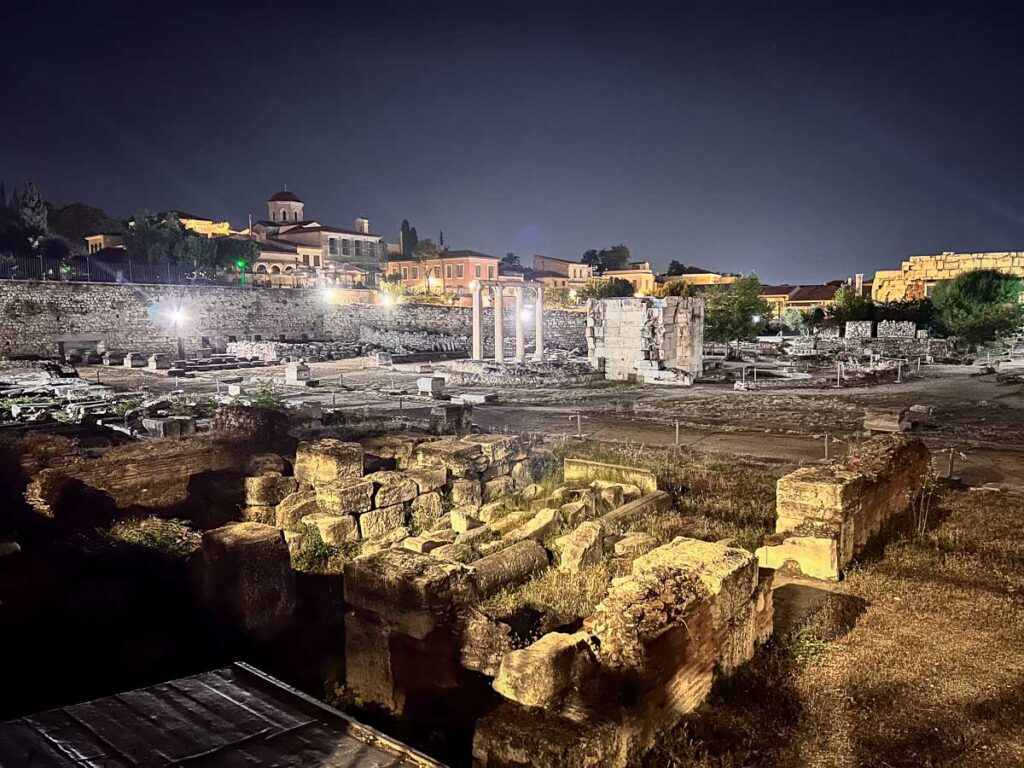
[0,663,440,768]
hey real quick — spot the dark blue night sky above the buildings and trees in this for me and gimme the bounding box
[0,0,1024,282]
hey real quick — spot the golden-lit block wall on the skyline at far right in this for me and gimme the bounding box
[871,251,1024,301]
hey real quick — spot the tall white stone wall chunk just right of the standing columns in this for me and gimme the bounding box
[587,296,703,384]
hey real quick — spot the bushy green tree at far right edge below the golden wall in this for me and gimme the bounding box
[932,269,1024,349]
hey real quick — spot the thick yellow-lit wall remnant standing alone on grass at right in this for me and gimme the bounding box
[757,436,931,580]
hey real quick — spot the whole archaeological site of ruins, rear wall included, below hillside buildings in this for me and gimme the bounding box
[0,281,1024,768]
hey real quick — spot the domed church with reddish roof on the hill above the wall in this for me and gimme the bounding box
[243,189,387,288]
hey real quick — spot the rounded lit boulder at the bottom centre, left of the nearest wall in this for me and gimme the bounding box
[493,632,592,709]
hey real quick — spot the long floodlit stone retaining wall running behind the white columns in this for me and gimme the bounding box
[0,281,587,355]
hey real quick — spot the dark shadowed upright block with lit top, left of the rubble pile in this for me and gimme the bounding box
[195,522,295,640]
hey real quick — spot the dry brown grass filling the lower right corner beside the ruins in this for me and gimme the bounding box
[645,492,1024,768]
